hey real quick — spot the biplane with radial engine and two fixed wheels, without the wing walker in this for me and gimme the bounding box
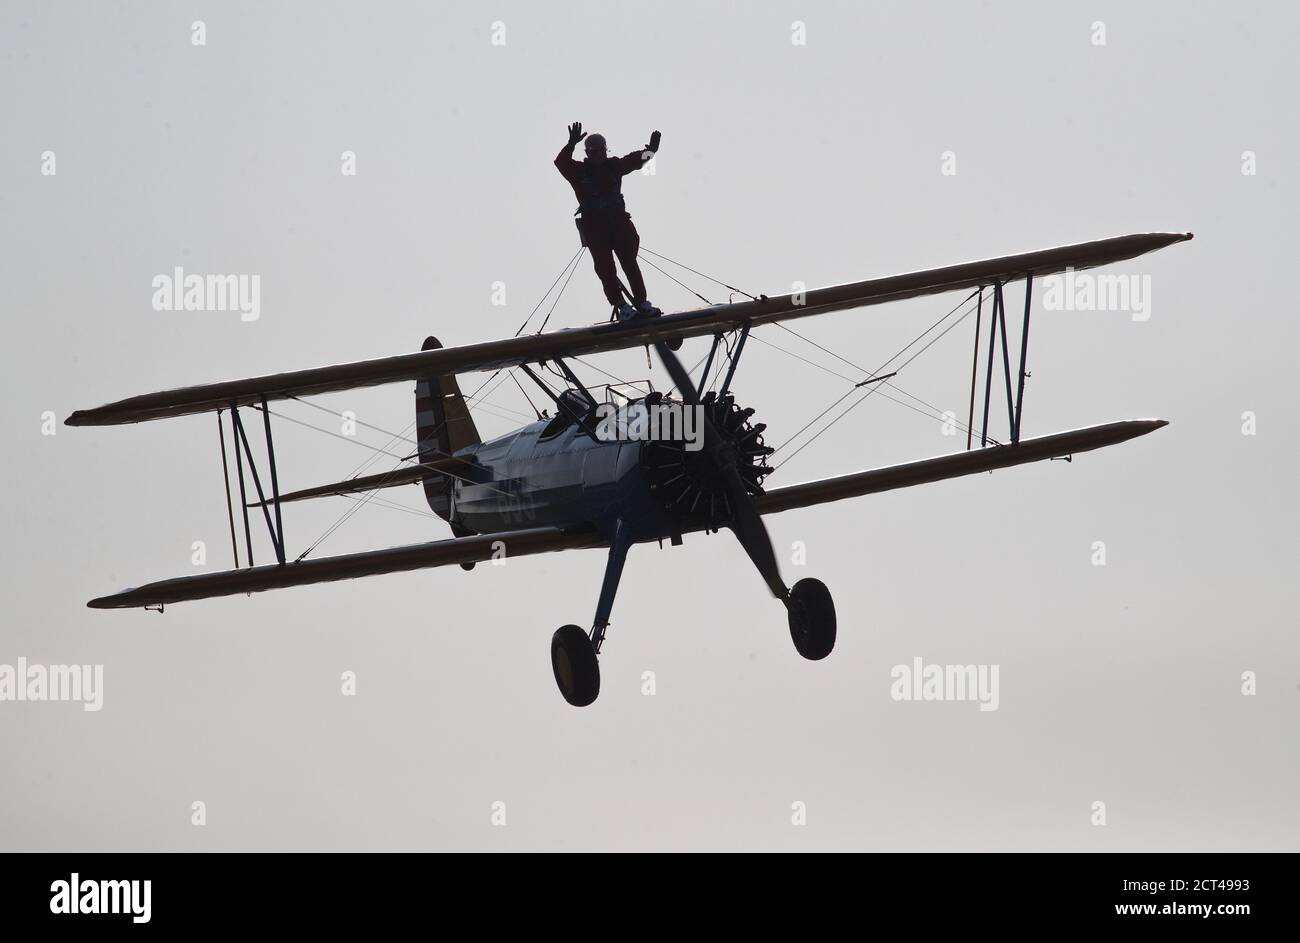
[66,233,1192,706]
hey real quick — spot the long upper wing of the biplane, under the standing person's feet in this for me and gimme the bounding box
[66,233,1192,425]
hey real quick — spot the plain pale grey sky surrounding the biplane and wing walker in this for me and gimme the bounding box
[0,1,1300,851]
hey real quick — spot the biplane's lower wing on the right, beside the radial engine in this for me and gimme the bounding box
[758,419,1169,514]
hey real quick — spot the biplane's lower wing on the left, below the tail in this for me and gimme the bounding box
[86,527,603,609]
